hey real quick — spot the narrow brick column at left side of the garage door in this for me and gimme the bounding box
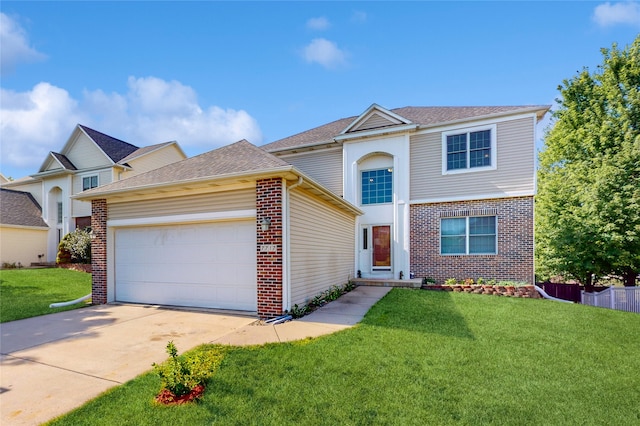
[91,199,107,305]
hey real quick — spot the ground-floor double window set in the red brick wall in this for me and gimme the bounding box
[440,216,497,254]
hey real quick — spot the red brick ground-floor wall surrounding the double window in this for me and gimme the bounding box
[410,197,534,284]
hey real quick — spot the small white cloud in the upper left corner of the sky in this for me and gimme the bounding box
[0,13,46,75]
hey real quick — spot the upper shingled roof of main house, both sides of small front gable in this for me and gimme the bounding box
[262,105,550,152]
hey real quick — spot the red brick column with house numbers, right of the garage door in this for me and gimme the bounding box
[256,178,283,318]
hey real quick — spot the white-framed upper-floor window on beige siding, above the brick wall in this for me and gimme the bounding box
[442,124,497,174]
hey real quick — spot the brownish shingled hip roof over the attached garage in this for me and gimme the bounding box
[82,139,291,198]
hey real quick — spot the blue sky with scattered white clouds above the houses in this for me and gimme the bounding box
[0,0,640,178]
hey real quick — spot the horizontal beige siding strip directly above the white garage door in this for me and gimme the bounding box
[107,188,256,220]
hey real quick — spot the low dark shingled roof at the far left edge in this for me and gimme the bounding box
[0,188,47,227]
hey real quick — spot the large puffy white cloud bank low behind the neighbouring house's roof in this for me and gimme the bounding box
[0,77,262,173]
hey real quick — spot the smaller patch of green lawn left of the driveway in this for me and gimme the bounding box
[0,268,91,322]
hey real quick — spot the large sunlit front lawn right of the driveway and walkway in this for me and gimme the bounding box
[47,289,640,425]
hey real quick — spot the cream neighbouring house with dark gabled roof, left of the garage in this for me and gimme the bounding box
[0,124,186,265]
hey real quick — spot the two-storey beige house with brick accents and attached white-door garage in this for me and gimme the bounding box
[79,104,549,317]
